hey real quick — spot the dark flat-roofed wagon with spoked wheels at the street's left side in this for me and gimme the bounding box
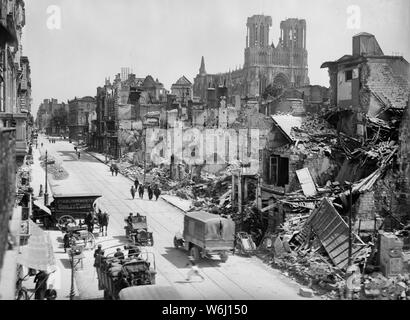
[33,193,101,231]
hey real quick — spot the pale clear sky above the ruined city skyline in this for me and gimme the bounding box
[23,0,410,114]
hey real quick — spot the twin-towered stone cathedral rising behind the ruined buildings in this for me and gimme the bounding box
[193,15,309,101]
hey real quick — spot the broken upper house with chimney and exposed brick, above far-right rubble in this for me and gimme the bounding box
[321,32,410,139]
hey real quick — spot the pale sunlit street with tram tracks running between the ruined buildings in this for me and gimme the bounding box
[33,137,310,300]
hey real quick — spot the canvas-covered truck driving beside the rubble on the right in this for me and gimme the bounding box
[174,211,235,262]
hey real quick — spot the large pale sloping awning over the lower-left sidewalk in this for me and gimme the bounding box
[17,220,56,273]
